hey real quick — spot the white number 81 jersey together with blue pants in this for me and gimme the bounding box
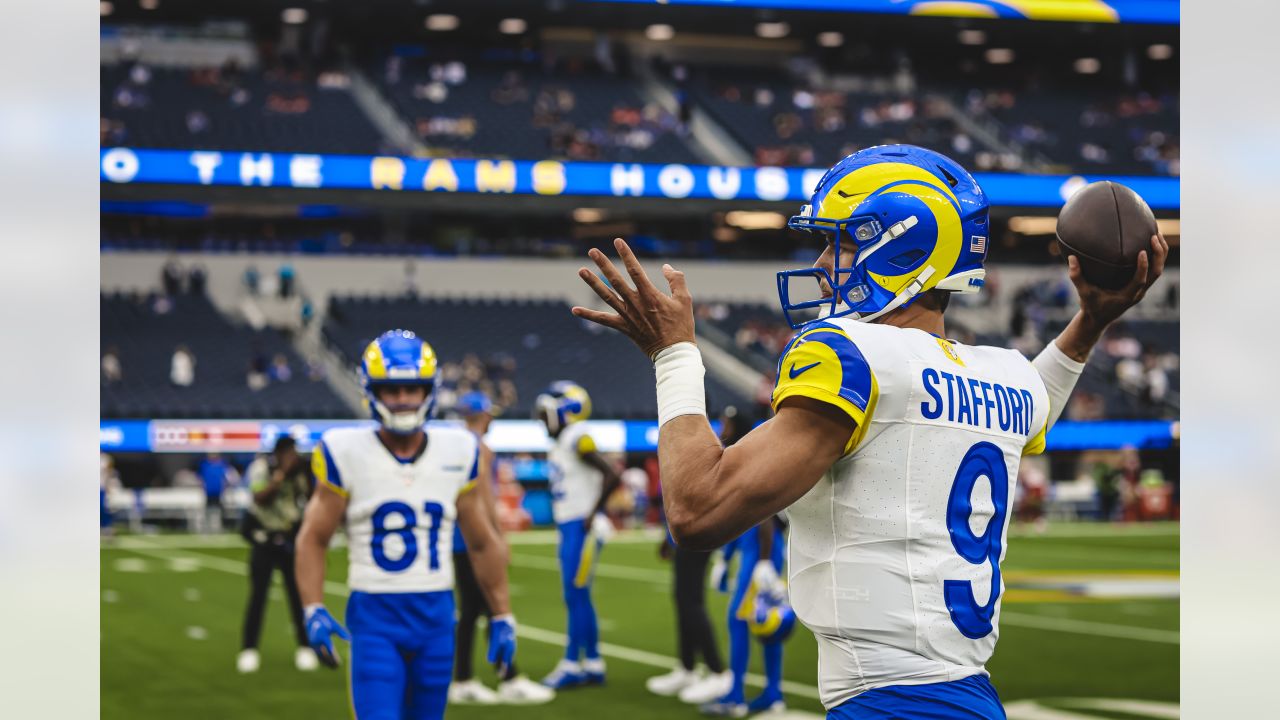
[312,425,479,720]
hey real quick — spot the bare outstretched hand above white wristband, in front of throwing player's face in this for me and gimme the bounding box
[572,238,694,359]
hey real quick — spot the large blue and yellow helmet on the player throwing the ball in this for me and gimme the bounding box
[778,145,988,328]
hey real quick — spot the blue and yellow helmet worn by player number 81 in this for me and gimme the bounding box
[360,331,436,434]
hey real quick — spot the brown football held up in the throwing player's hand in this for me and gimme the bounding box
[1057,181,1156,290]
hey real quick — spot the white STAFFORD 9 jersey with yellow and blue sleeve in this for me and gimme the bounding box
[773,319,1048,708]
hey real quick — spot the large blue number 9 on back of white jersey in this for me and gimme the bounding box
[942,441,1009,639]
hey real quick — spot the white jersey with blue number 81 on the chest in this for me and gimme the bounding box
[311,425,480,593]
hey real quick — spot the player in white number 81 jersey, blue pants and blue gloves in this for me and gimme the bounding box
[297,331,516,720]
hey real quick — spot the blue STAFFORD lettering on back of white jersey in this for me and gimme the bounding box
[920,368,1036,436]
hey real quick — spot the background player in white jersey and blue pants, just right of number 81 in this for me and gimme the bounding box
[535,380,621,689]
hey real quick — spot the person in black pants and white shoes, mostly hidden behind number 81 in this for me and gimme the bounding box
[449,392,556,705]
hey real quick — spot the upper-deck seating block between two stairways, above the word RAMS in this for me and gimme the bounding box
[370,58,698,163]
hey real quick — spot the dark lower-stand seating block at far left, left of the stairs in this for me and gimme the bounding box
[101,289,351,419]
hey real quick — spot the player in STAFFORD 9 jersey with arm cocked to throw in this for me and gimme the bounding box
[572,145,1169,719]
